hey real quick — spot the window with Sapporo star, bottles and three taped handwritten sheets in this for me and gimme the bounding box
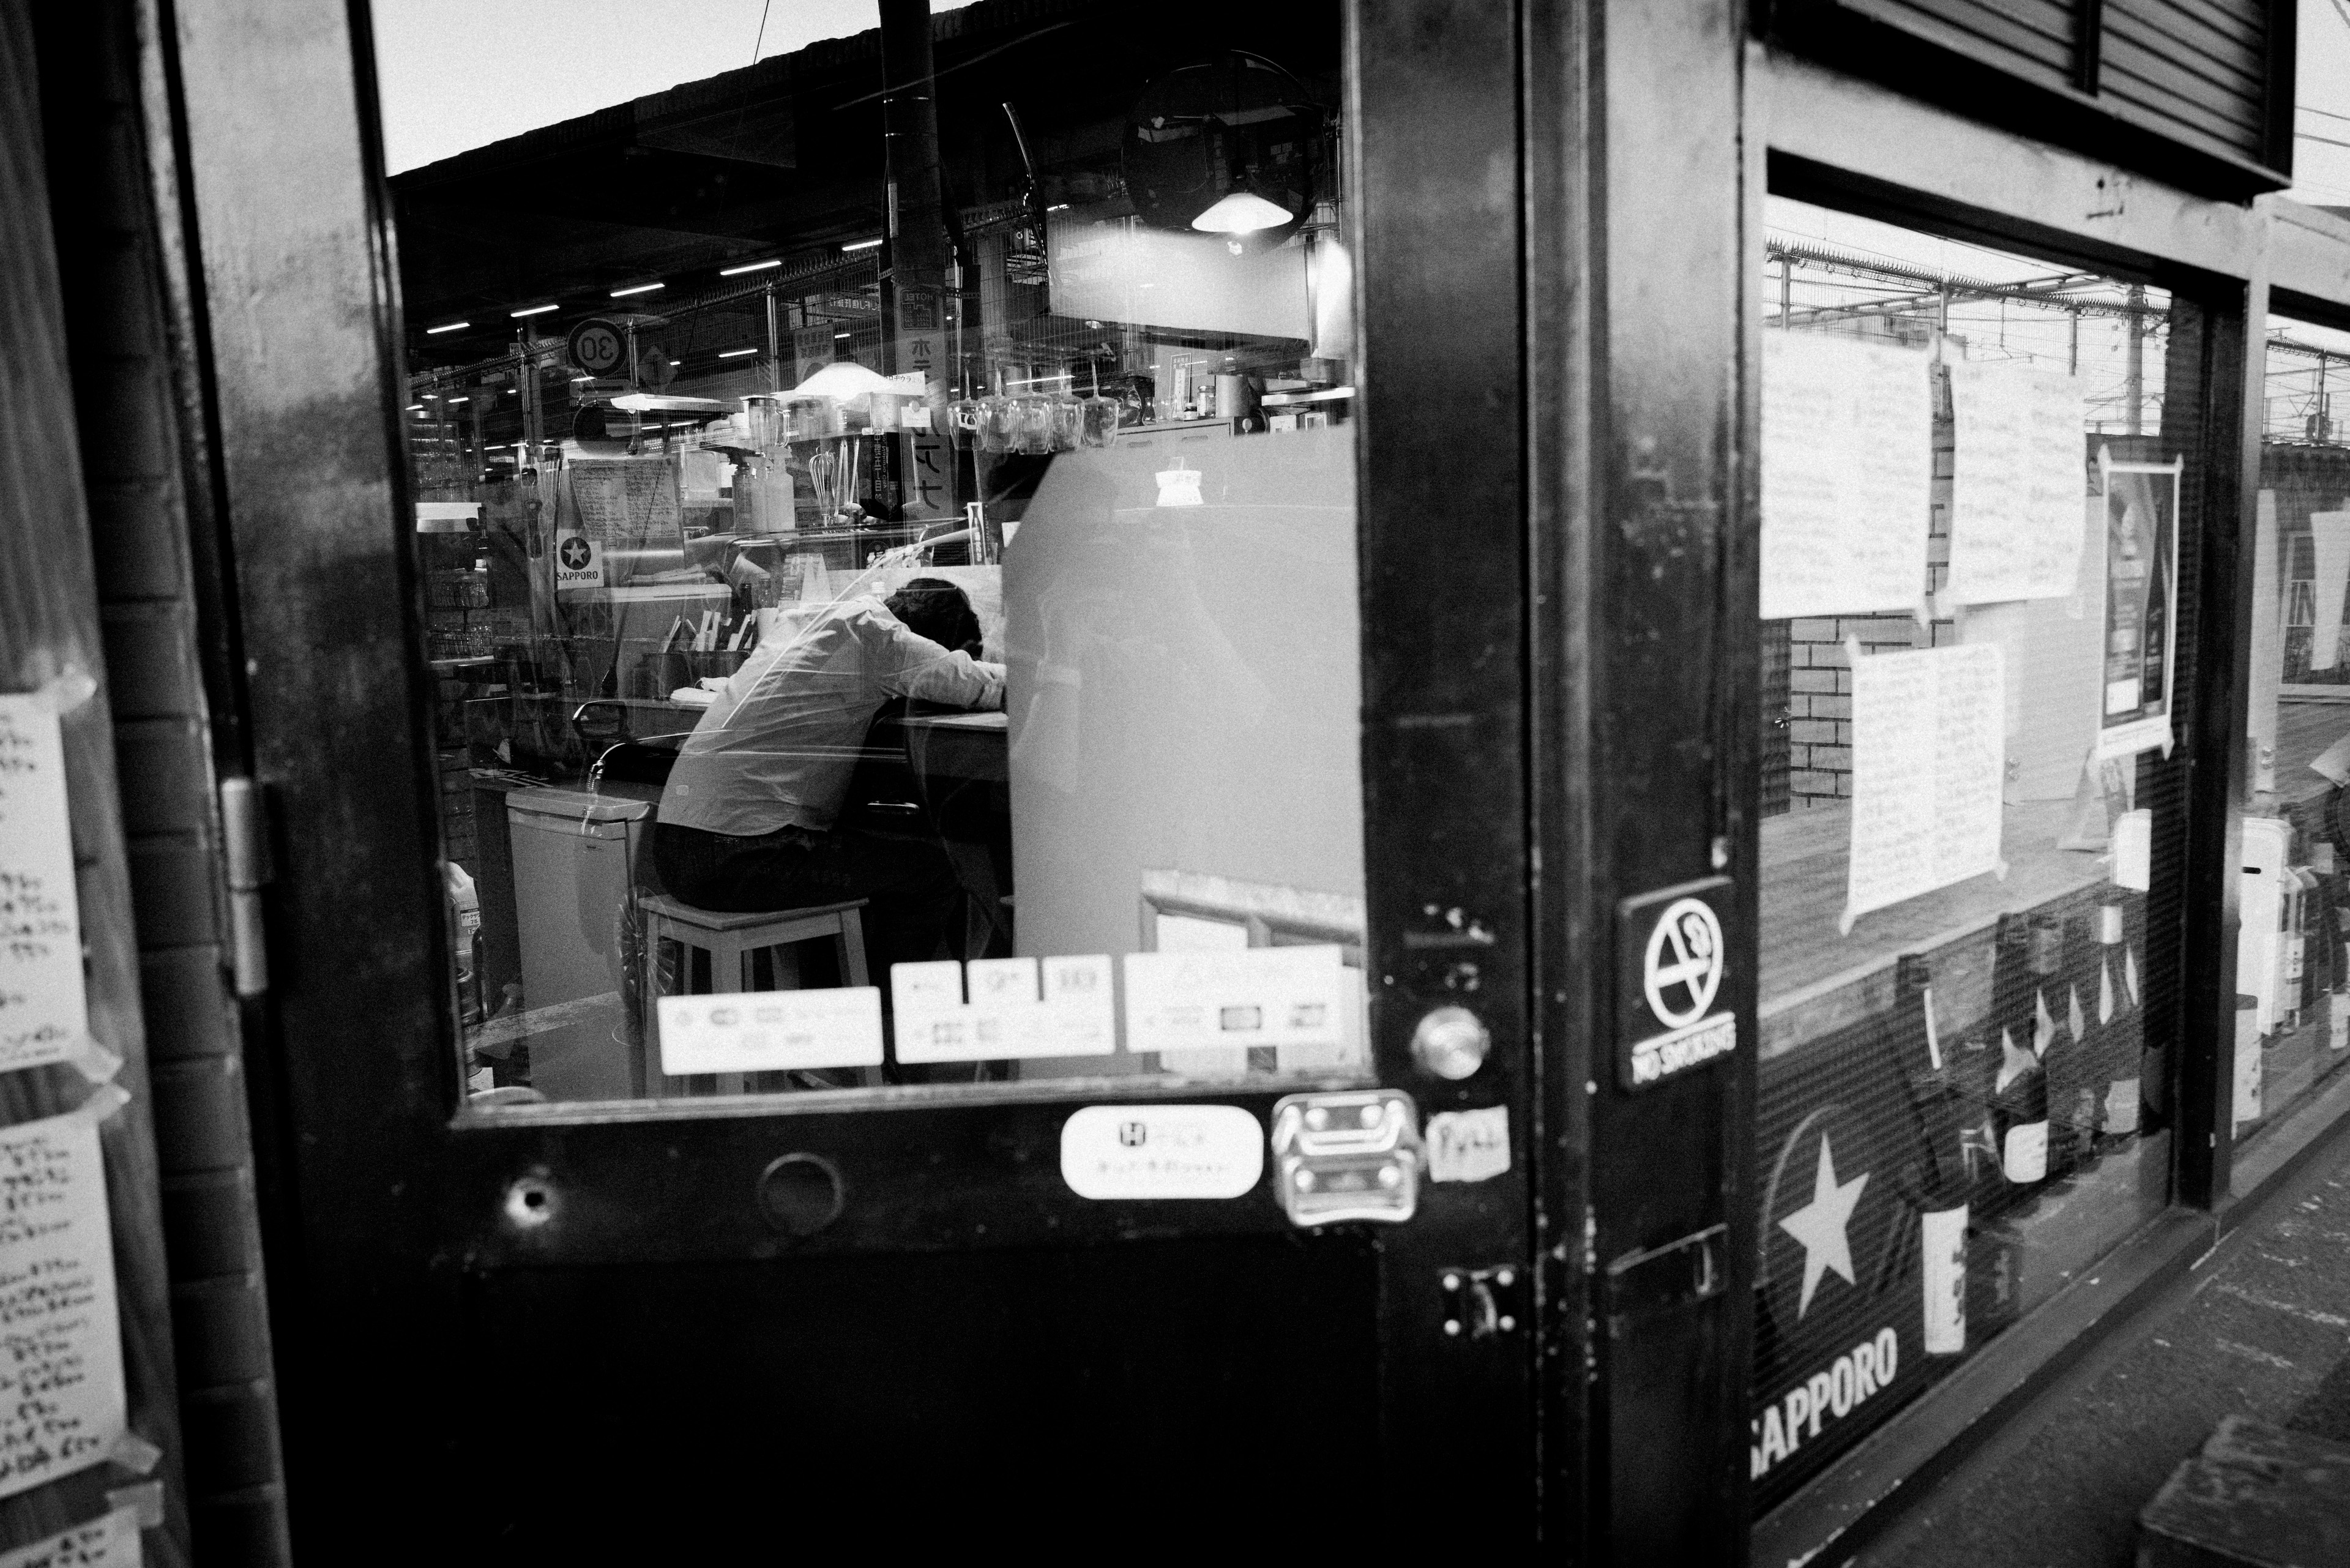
[1751,198,2202,1507]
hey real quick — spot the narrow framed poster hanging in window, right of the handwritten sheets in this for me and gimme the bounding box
[2096,447,2185,762]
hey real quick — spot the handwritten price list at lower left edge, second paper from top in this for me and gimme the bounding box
[0,1086,129,1498]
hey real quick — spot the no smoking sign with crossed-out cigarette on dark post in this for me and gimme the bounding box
[1617,877,1739,1088]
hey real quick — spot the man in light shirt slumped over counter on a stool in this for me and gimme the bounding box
[654,578,1004,999]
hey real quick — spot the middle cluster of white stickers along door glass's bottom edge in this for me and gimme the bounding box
[889,954,1119,1062]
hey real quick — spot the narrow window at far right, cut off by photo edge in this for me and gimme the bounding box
[2232,318,2350,1166]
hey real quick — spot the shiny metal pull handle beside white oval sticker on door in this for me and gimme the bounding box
[1274,1088,1427,1225]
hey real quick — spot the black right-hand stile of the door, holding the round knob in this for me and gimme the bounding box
[1351,0,1535,1547]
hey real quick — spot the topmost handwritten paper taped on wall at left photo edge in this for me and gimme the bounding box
[0,696,89,1072]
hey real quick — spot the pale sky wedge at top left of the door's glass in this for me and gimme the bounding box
[374,0,971,174]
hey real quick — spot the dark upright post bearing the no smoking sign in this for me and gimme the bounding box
[1530,0,1760,1563]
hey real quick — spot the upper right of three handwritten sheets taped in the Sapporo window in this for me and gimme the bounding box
[1946,364,2089,604]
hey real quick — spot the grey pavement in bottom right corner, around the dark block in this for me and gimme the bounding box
[1857,1135,2350,1568]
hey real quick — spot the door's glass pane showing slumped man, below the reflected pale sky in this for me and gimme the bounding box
[392,2,1368,1110]
